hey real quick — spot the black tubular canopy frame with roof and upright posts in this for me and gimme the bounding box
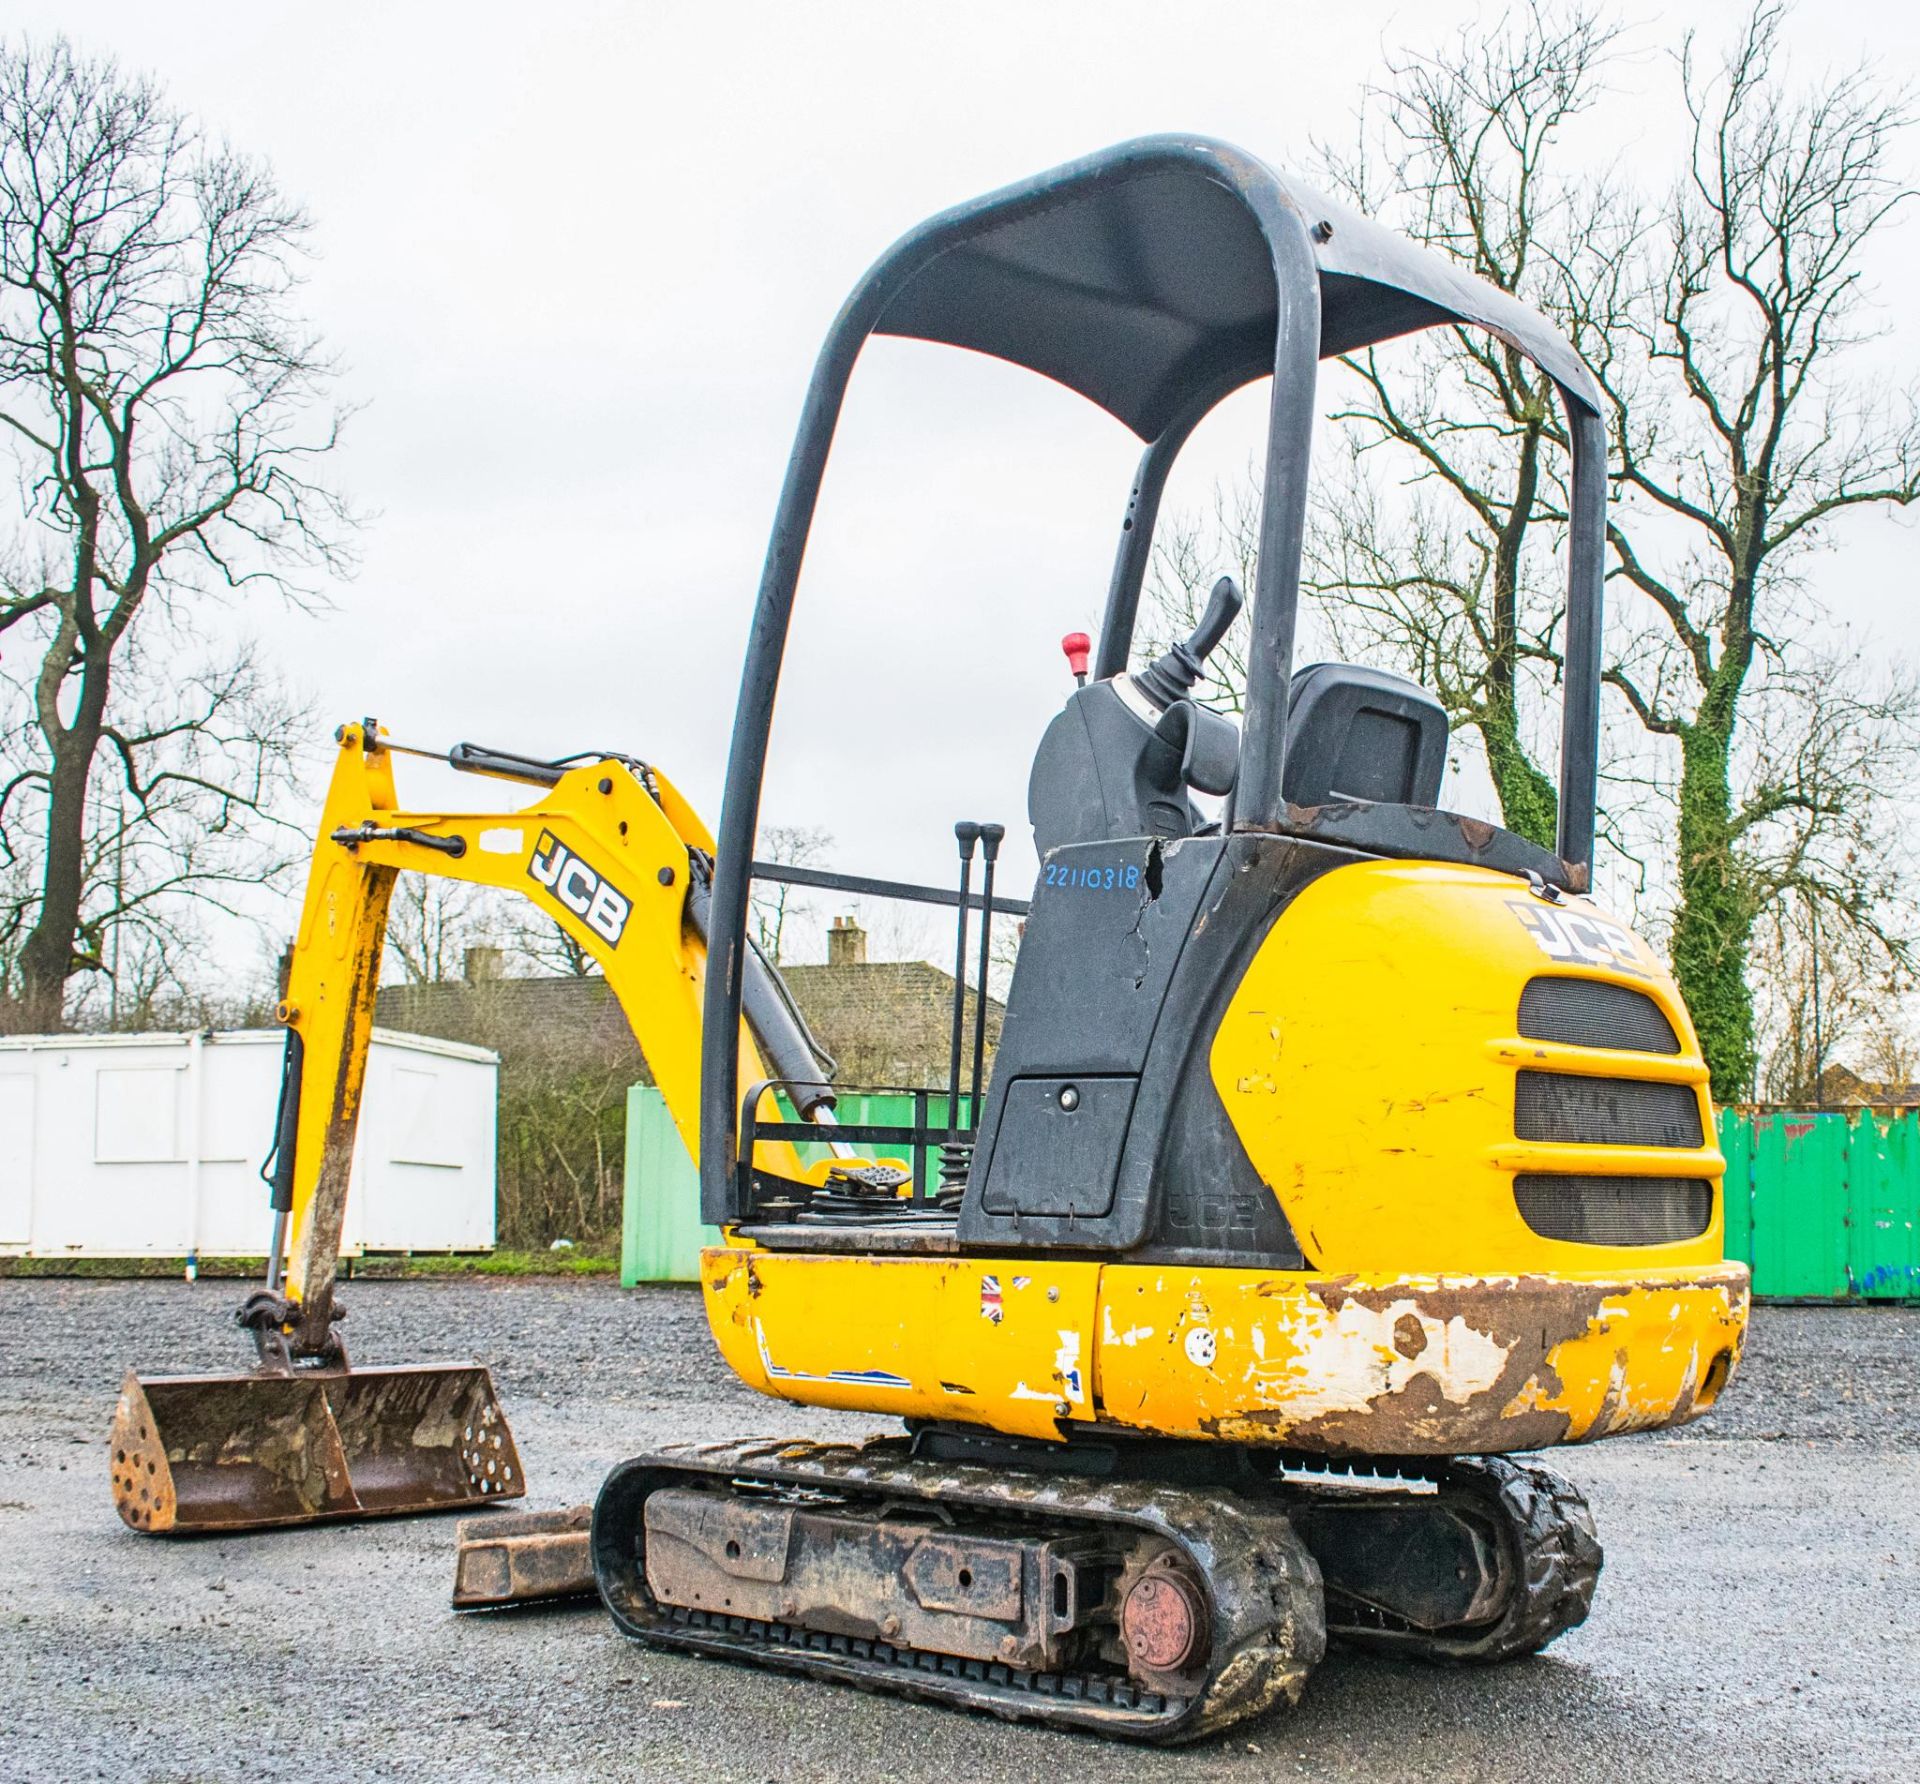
[701,136,1607,1223]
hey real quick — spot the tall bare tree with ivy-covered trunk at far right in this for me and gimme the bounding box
[1563,0,1920,1097]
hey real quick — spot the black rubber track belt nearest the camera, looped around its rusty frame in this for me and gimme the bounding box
[593,1438,1327,1744]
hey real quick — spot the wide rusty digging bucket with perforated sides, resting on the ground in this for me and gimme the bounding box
[111,1363,526,1536]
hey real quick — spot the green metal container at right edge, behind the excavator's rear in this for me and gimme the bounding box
[1720,1108,1920,1300]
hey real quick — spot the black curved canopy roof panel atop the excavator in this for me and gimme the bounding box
[872,136,1599,440]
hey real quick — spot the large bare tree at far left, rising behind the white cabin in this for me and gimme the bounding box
[0,40,349,1027]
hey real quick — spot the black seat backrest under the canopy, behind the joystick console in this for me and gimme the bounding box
[1283,663,1446,805]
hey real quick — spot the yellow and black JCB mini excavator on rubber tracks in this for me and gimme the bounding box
[117,136,1747,1742]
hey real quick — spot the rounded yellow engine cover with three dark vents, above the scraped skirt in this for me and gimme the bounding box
[1210,860,1726,1275]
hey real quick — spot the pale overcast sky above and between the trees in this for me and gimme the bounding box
[26,0,1920,975]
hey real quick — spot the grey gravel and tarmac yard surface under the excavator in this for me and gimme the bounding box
[0,1281,1920,1784]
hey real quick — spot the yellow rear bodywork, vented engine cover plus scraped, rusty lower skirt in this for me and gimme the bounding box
[703,860,1747,1456]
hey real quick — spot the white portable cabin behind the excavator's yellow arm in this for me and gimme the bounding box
[0,1029,499,1258]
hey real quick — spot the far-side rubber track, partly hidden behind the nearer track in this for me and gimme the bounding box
[1329,1456,1605,1665]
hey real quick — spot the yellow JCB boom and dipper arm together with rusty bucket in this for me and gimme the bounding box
[111,720,837,1534]
